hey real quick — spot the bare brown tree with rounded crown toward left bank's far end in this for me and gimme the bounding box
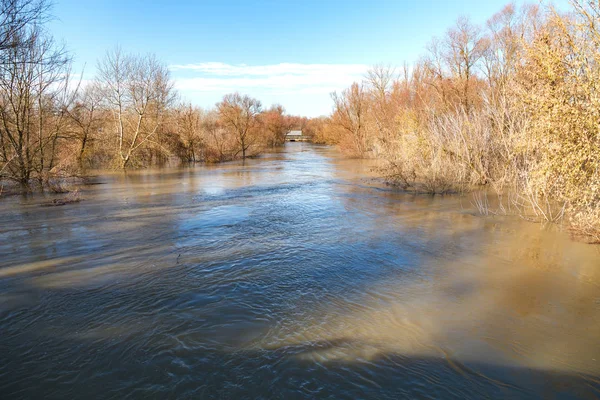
[217,93,262,160]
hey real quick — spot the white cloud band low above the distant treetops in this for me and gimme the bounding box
[170,62,369,116]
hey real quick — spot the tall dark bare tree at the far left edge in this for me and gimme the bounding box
[0,8,70,187]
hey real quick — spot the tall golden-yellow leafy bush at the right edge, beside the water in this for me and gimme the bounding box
[519,2,600,240]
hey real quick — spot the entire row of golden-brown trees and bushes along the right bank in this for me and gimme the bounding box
[315,0,600,242]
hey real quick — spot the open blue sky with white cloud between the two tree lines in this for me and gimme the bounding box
[50,0,567,116]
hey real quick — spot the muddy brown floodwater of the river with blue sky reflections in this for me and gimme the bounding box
[0,143,600,399]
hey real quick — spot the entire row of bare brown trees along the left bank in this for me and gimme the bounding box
[0,0,308,190]
